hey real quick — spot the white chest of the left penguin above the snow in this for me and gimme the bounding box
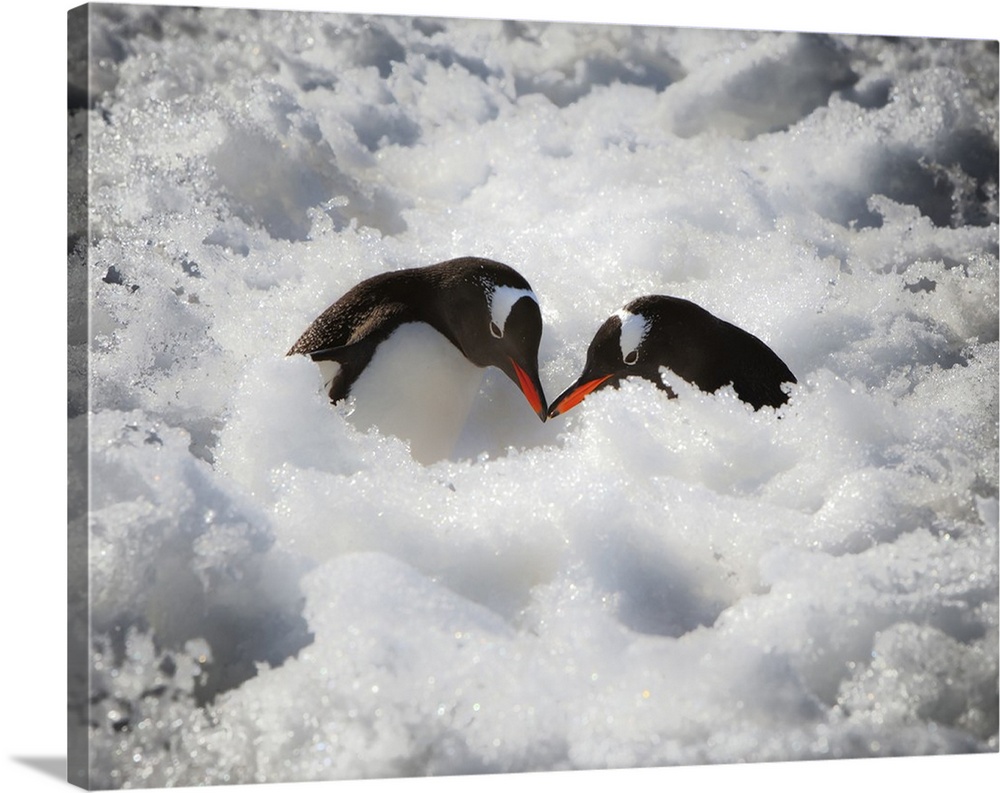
[321,322,485,463]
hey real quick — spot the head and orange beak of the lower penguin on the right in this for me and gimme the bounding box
[549,308,660,418]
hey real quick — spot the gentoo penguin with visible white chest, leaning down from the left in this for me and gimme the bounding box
[287,256,548,462]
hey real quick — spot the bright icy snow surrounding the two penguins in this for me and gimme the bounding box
[70,7,998,787]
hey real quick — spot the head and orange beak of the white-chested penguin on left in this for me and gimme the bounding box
[462,284,548,421]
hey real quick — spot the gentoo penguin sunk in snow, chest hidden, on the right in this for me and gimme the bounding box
[549,295,796,418]
